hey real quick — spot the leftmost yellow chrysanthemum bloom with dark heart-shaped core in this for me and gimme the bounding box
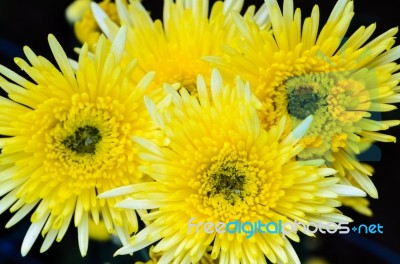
[0,28,156,255]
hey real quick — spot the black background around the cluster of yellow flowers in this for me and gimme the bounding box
[0,0,400,264]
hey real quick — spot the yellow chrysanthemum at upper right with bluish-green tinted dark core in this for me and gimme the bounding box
[208,0,400,214]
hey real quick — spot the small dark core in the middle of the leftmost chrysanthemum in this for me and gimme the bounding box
[62,126,101,154]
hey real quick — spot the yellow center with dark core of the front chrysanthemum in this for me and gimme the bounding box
[189,142,284,221]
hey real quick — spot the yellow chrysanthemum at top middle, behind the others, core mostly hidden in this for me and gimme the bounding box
[92,0,266,96]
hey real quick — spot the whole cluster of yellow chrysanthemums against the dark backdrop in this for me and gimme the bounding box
[0,0,400,263]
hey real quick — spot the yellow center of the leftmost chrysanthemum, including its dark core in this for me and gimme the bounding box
[21,94,140,200]
